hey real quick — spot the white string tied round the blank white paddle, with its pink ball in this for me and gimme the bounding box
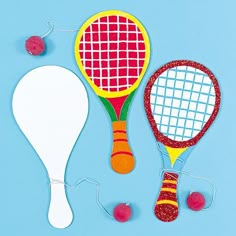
[49,178,132,223]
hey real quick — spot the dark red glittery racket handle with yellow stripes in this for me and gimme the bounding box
[155,172,179,222]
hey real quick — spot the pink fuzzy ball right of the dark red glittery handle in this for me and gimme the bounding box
[187,192,206,211]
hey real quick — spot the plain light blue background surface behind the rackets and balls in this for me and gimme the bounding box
[0,0,236,236]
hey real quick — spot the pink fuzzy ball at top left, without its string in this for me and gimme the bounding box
[25,36,45,56]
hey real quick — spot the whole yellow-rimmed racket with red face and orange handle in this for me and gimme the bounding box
[75,10,150,174]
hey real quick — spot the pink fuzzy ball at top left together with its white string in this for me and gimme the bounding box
[25,21,79,56]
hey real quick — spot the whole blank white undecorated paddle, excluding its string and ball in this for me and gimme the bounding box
[12,66,88,228]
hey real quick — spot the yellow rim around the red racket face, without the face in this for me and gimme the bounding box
[74,10,150,98]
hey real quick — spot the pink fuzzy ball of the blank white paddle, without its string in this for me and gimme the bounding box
[113,203,132,222]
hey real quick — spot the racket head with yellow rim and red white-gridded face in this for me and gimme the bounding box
[74,10,150,98]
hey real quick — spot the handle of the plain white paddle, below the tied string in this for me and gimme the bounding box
[48,184,73,229]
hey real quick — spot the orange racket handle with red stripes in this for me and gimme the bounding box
[111,121,135,174]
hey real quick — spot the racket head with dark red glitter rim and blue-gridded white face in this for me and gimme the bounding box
[144,60,221,148]
